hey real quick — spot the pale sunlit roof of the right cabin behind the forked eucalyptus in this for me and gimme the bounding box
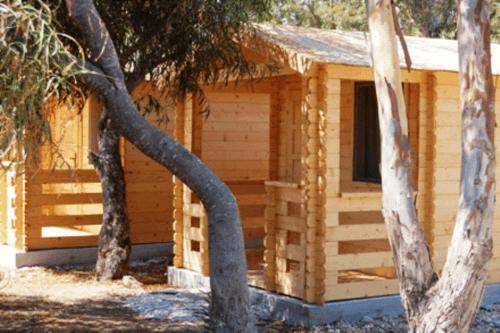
[256,24,500,75]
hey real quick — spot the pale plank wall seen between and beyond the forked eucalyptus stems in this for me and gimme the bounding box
[431,72,500,283]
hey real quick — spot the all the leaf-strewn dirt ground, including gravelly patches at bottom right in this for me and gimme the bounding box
[0,259,500,333]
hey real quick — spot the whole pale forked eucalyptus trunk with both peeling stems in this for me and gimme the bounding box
[367,0,495,332]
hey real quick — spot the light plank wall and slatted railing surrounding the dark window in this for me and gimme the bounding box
[323,65,430,301]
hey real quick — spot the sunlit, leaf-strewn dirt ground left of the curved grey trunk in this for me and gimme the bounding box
[0,260,203,332]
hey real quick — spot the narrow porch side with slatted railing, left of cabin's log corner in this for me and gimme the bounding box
[264,75,310,302]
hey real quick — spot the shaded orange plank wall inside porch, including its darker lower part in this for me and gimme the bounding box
[200,79,272,243]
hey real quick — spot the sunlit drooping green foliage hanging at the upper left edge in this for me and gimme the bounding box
[0,0,82,163]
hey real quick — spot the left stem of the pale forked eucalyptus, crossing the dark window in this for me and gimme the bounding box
[368,0,436,320]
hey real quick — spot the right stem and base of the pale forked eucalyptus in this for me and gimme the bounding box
[421,0,496,332]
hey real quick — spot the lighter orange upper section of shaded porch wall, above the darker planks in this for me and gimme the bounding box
[201,92,270,182]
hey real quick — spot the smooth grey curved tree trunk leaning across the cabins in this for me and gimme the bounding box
[66,0,256,332]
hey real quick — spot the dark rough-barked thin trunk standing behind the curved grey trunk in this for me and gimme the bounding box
[89,111,130,280]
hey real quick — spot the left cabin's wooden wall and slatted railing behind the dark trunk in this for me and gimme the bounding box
[23,83,174,250]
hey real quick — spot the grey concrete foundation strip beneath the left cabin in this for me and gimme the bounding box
[0,242,173,268]
